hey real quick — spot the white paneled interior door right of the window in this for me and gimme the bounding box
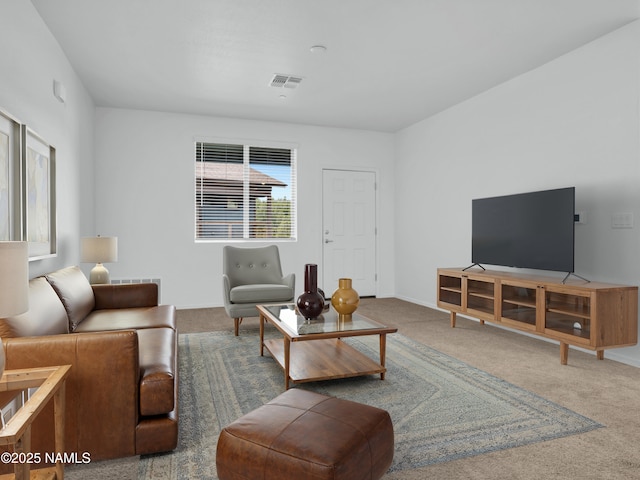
[322,170,376,296]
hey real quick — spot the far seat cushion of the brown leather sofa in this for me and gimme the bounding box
[75,305,176,332]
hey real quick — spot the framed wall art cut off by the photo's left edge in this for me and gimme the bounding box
[0,110,22,241]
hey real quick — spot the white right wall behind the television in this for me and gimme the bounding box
[395,22,640,365]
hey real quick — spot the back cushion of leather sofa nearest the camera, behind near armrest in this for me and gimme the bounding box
[0,277,69,338]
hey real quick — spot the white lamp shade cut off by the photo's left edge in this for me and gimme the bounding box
[0,242,29,318]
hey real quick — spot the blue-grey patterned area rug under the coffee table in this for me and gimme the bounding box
[138,331,602,480]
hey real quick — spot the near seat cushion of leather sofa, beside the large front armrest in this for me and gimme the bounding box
[137,328,178,416]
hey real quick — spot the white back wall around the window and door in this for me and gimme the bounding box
[95,108,395,308]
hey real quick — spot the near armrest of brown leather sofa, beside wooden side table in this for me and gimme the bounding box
[3,330,140,460]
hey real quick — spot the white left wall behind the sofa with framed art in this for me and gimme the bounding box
[0,0,94,276]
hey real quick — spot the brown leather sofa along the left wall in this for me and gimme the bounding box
[0,267,178,461]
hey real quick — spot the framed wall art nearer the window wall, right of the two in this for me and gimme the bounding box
[22,126,57,260]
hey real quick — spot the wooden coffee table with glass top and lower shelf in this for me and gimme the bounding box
[258,303,398,389]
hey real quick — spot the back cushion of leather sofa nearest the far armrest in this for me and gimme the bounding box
[45,267,95,332]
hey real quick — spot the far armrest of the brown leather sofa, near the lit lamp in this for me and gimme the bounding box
[91,283,158,310]
